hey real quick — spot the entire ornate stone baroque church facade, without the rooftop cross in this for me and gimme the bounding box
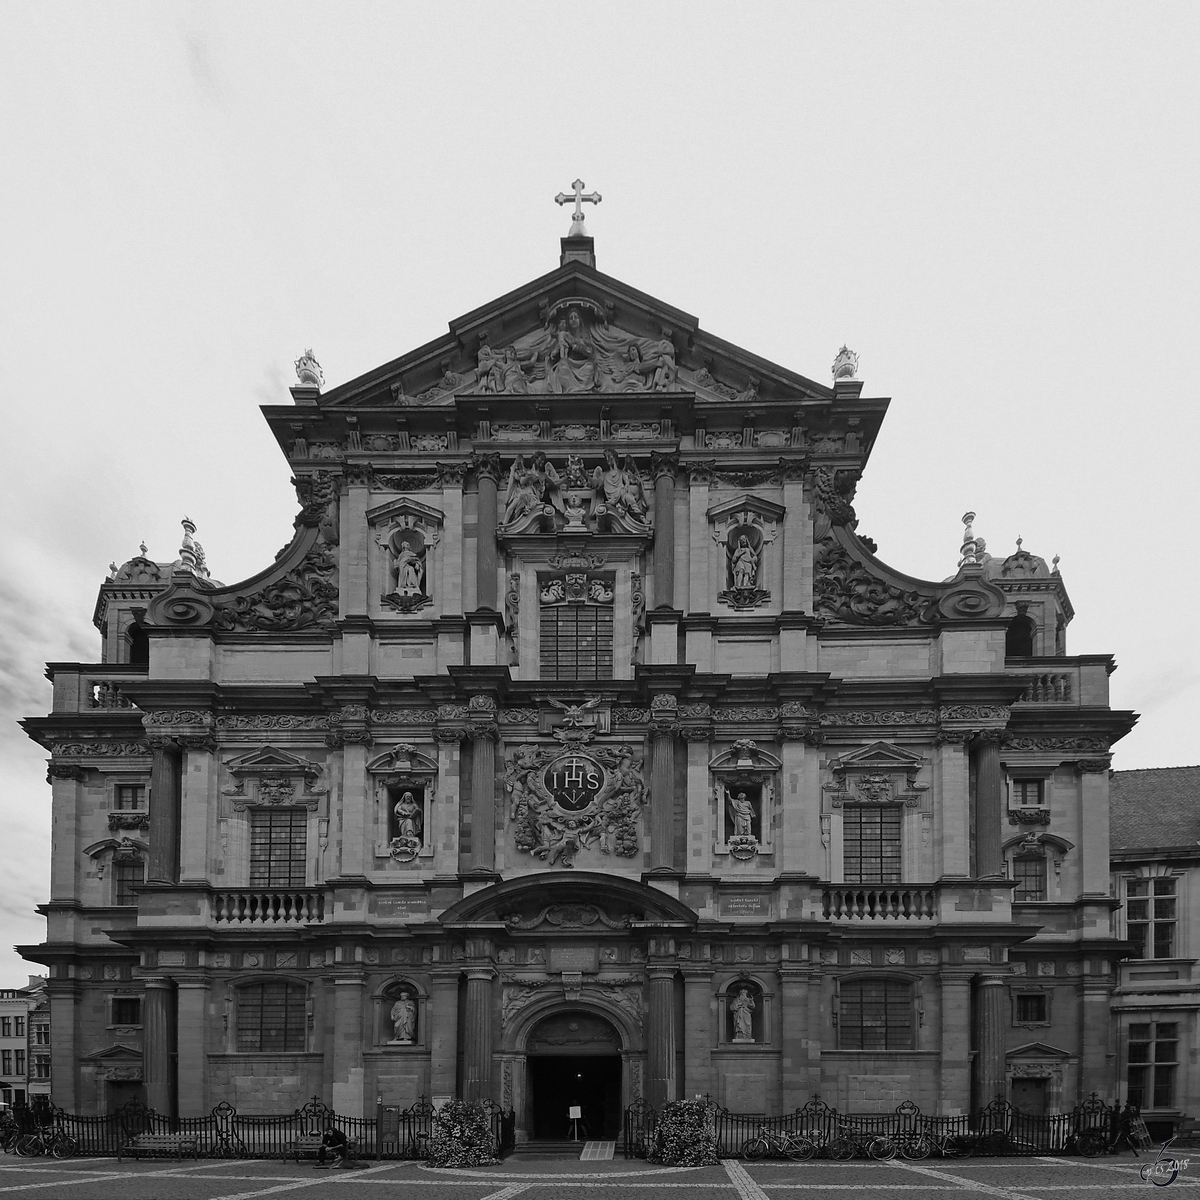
[23,218,1133,1138]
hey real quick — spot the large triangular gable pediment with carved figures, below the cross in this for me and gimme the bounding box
[319,262,833,408]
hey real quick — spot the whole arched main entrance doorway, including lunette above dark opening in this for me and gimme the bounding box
[527,1013,622,1141]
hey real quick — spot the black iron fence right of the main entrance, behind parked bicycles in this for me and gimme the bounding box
[624,1093,1121,1158]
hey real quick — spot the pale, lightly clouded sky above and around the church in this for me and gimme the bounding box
[0,0,1200,986]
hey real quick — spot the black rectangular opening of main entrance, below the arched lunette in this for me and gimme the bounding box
[528,1055,620,1141]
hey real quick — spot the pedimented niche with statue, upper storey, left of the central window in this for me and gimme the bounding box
[366,496,445,614]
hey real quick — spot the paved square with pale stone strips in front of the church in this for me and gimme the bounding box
[0,1154,1200,1200]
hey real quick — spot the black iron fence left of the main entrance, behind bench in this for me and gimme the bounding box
[17,1097,515,1159]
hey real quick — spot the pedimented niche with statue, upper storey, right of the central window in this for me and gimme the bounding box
[706,493,786,612]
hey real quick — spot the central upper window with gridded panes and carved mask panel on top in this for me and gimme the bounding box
[538,572,613,680]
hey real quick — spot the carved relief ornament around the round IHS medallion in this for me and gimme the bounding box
[504,728,648,866]
